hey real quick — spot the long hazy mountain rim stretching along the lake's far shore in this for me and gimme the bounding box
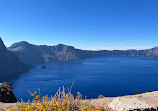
[8,41,158,64]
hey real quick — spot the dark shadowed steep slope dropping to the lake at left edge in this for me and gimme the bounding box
[0,38,31,80]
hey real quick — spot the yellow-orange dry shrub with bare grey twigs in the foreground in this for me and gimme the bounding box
[2,83,110,111]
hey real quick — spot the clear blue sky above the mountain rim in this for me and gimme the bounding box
[0,0,158,50]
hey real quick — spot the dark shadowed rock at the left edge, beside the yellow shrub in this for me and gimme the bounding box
[0,82,17,103]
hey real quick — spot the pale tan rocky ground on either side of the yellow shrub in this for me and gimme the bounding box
[0,91,158,111]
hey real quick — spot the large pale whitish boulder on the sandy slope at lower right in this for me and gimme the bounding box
[108,98,152,111]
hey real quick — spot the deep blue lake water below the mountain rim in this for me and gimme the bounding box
[10,57,158,101]
